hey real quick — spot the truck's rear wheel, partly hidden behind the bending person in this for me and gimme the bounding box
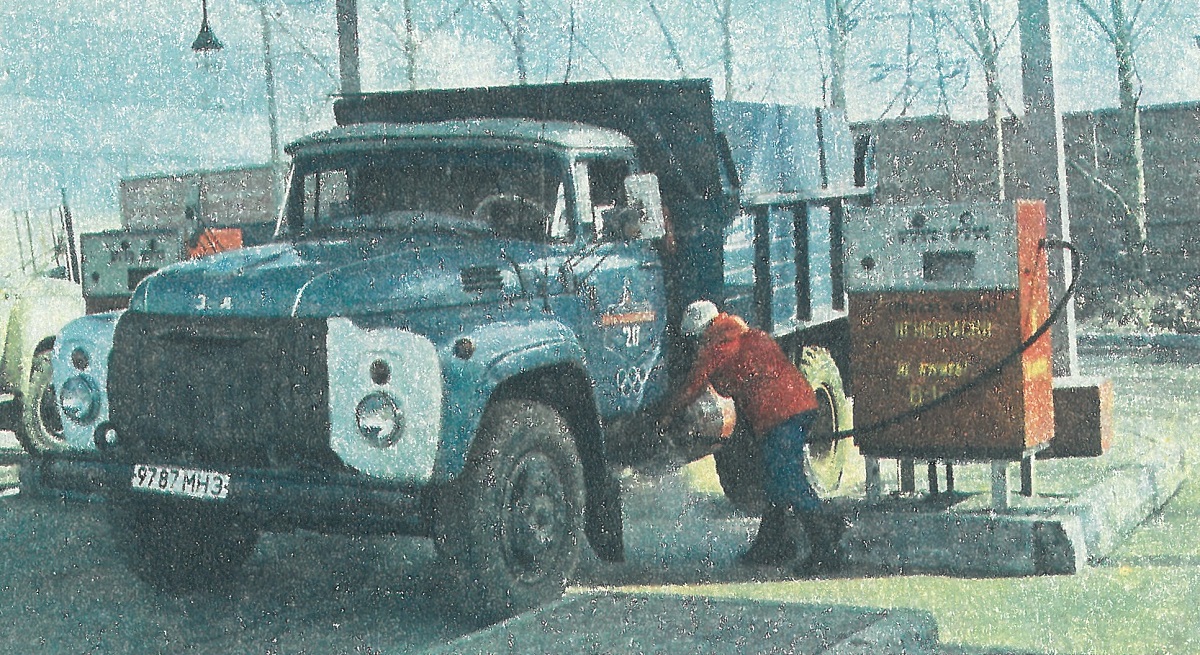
[713,347,865,516]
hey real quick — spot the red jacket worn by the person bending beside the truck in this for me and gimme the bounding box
[671,313,817,435]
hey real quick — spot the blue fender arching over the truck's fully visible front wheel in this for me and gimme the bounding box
[433,319,584,481]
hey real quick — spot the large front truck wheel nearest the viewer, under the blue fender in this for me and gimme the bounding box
[434,399,584,623]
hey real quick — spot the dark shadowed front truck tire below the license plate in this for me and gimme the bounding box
[109,494,258,595]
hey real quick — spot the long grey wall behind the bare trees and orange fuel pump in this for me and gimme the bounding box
[856,102,1200,276]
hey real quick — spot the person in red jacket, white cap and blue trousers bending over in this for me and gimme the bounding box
[666,300,841,569]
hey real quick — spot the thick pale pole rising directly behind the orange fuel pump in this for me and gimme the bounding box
[1008,0,1079,377]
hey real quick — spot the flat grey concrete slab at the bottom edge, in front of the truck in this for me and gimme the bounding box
[433,593,937,655]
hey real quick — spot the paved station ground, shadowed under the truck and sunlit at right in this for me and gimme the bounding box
[0,338,1185,655]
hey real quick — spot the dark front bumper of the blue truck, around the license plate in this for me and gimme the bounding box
[20,456,432,536]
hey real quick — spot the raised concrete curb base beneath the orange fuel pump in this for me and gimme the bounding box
[838,441,1186,577]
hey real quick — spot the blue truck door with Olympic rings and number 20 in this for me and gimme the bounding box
[556,157,666,417]
